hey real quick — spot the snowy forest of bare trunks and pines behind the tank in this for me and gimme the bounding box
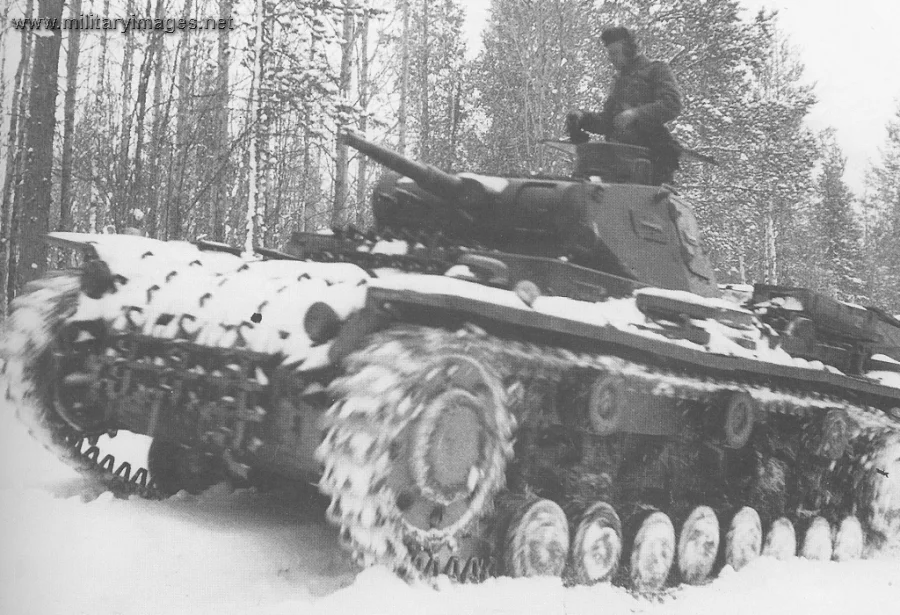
[0,0,900,315]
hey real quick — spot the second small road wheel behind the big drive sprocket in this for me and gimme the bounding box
[572,502,622,585]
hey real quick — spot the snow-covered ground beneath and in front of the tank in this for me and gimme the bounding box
[0,407,900,615]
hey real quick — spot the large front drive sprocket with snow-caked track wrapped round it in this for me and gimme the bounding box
[317,327,515,574]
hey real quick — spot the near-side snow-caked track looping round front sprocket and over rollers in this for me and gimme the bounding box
[319,326,900,574]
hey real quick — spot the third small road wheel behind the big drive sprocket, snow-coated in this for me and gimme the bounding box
[630,511,675,592]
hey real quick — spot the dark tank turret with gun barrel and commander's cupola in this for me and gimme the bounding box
[346,132,718,296]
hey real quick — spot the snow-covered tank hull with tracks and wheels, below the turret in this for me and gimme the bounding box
[2,235,900,590]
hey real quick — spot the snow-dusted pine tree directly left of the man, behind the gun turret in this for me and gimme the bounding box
[468,0,596,173]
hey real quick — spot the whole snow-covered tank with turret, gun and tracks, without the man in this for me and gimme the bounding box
[2,133,900,591]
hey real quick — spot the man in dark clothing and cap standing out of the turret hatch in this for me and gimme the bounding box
[566,26,681,184]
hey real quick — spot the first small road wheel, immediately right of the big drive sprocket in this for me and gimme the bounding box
[503,499,569,577]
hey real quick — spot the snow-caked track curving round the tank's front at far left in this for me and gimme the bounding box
[0,272,163,499]
